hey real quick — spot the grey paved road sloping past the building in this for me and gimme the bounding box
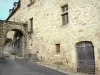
[0,59,67,75]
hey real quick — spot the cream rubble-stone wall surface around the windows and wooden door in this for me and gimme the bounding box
[7,0,100,74]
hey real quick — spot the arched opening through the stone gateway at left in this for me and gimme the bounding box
[3,29,24,56]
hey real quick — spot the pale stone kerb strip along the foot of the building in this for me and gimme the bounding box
[37,62,94,75]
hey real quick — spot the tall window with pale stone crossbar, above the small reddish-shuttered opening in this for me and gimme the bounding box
[62,4,68,25]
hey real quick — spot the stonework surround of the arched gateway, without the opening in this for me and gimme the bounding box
[0,22,27,56]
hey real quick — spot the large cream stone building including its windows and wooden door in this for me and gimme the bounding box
[4,0,100,75]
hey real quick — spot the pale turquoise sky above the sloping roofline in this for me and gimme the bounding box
[0,0,18,20]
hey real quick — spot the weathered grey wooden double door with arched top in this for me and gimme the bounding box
[76,41,95,74]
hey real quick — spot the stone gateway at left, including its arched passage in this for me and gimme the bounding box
[0,20,27,57]
